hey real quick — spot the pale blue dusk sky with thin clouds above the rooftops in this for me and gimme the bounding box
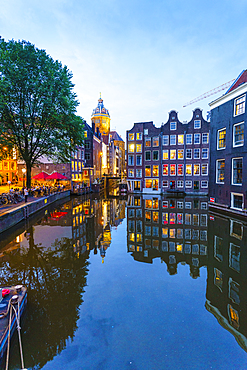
[0,0,247,139]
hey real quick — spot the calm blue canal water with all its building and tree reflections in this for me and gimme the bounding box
[0,196,247,370]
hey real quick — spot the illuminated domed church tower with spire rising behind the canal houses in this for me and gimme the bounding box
[91,93,111,142]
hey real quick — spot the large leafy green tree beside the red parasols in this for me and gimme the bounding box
[0,38,84,187]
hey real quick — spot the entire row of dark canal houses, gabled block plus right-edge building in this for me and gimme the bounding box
[126,70,247,216]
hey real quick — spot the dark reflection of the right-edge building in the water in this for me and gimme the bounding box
[206,216,247,351]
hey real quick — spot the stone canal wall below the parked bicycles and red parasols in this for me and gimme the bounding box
[0,190,70,233]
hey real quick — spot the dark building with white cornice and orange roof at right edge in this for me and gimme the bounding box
[209,70,247,215]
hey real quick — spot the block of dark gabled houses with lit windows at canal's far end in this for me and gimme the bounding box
[127,109,209,195]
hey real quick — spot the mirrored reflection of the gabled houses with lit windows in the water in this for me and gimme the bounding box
[127,196,208,278]
